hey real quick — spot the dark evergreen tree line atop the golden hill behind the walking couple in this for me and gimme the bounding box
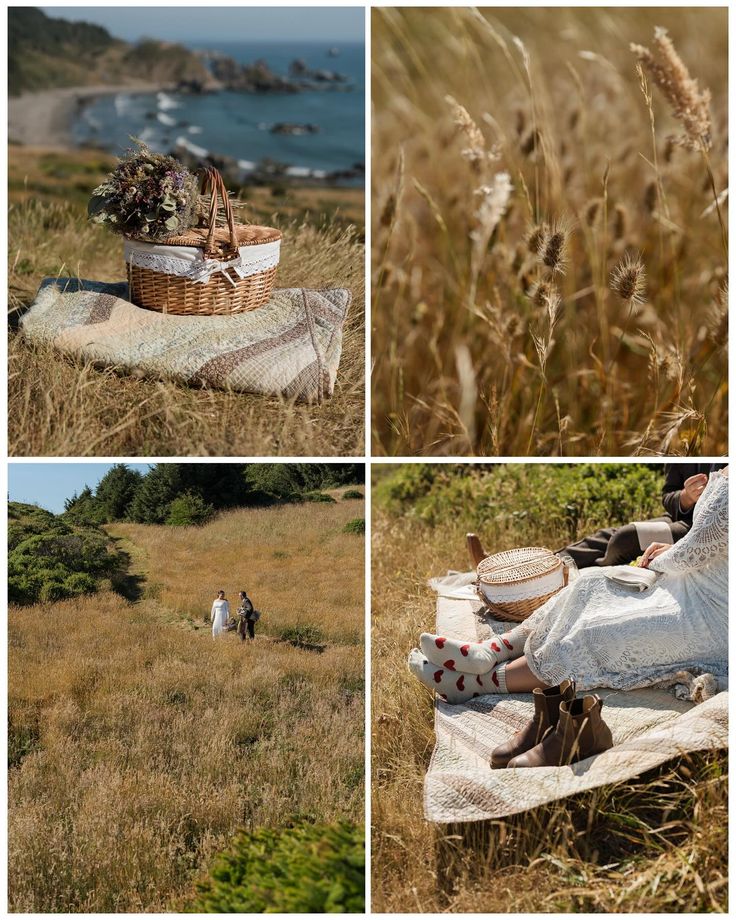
[64,463,365,526]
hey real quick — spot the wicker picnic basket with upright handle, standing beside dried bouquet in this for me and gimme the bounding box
[125,167,281,316]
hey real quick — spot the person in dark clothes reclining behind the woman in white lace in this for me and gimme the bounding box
[558,463,727,569]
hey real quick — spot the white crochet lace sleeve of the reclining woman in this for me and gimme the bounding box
[649,474,728,575]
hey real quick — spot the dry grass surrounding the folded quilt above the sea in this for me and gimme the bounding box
[8,146,365,456]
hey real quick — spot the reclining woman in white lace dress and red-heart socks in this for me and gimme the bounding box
[409,468,728,703]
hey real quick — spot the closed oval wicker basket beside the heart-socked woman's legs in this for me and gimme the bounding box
[477,546,568,623]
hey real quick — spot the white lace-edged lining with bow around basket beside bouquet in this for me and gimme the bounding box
[124,239,281,285]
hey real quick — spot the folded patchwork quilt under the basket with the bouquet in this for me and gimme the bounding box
[21,278,351,402]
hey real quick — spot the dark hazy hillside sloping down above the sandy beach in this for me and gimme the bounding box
[8,7,211,96]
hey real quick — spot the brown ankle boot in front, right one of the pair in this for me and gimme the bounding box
[507,695,613,769]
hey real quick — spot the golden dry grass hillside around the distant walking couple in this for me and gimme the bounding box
[9,501,364,912]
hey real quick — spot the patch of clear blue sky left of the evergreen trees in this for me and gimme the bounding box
[8,463,151,514]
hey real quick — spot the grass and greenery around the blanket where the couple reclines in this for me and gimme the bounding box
[371,464,728,914]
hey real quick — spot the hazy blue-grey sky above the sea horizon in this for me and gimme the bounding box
[41,6,365,43]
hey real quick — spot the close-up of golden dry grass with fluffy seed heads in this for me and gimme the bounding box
[371,7,728,456]
